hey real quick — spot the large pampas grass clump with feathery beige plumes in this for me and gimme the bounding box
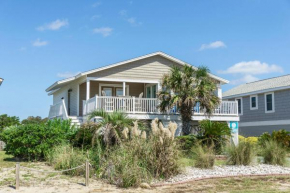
[100,120,179,187]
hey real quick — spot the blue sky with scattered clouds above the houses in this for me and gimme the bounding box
[0,0,290,119]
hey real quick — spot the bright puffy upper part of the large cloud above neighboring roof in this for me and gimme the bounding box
[219,60,283,75]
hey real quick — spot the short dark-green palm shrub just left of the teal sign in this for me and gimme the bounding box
[198,120,231,154]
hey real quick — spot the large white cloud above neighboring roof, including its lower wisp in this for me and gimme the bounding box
[218,60,283,85]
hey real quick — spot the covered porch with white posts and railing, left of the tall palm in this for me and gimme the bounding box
[78,77,160,116]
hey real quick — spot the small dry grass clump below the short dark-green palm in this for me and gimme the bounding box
[192,145,215,168]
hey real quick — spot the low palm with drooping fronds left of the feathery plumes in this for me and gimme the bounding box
[89,110,134,146]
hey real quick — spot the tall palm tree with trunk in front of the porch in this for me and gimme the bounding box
[158,65,220,135]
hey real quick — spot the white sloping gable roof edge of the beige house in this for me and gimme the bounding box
[45,52,229,92]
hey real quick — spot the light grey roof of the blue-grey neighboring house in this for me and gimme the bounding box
[223,75,290,99]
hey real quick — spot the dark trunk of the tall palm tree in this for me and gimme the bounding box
[180,104,193,135]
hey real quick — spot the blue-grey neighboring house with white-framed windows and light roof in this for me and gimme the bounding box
[223,75,290,136]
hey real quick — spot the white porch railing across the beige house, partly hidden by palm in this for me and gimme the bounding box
[83,96,238,116]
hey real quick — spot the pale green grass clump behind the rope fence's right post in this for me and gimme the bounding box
[46,143,88,175]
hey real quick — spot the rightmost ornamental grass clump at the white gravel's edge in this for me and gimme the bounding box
[261,140,287,165]
